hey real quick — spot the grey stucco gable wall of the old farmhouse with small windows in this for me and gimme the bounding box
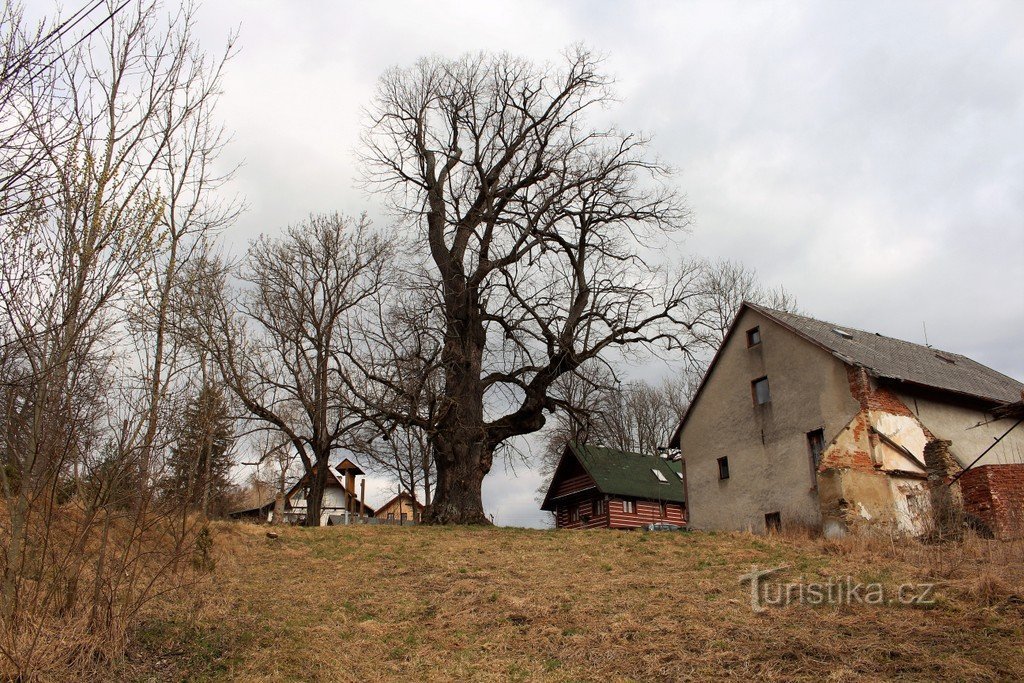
[679,309,860,531]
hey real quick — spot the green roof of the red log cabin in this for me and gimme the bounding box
[548,442,685,503]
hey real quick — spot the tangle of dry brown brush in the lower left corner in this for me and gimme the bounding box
[0,502,212,680]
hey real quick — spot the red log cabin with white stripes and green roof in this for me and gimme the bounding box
[541,443,686,529]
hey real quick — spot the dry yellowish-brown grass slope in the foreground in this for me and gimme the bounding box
[123,523,1024,681]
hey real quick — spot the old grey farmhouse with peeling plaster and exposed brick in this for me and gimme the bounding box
[671,303,1024,536]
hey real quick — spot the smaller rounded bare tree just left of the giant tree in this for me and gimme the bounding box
[189,214,392,526]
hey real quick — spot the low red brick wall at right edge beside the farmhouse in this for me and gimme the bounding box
[959,465,1024,538]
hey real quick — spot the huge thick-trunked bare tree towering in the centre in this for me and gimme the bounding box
[364,48,708,523]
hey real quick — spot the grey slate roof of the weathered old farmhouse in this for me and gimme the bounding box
[745,303,1024,402]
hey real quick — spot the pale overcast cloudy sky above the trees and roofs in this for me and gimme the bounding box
[39,0,1024,524]
